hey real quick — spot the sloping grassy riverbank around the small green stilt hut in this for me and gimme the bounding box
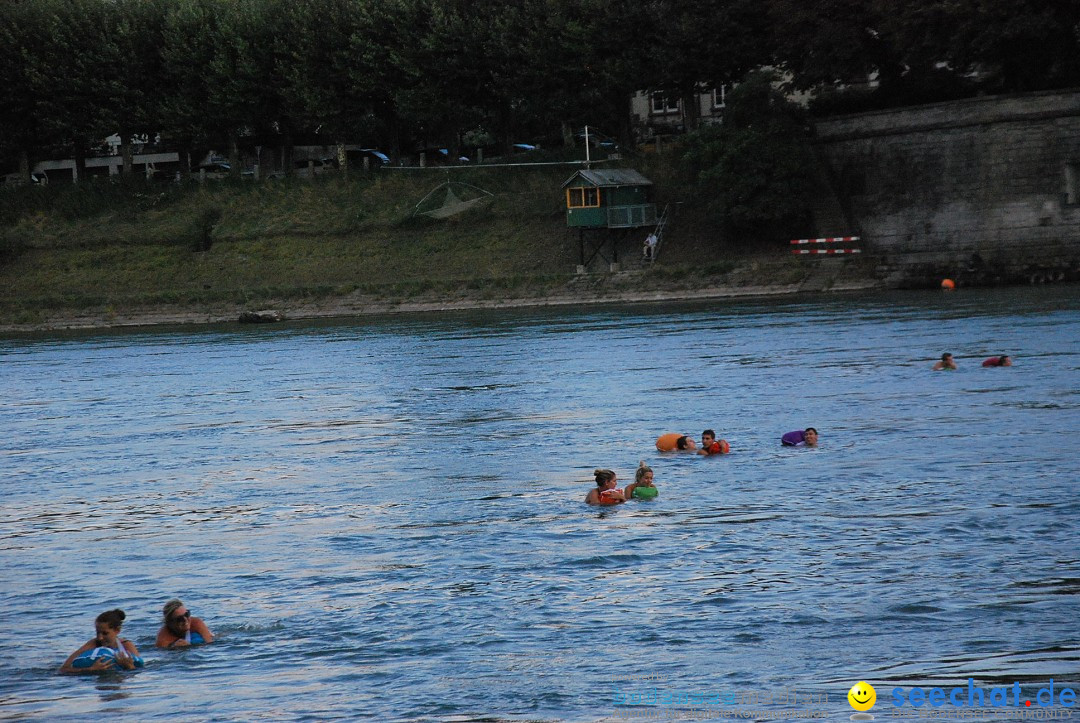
[0,158,868,329]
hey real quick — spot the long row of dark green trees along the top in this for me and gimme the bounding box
[0,0,1080,171]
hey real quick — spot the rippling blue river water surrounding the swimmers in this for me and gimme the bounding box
[0,286,1080,721]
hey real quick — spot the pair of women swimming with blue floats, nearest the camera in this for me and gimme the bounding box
[60,598,214,673]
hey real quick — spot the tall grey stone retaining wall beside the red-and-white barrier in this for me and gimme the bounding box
[816,91,1080,283]
